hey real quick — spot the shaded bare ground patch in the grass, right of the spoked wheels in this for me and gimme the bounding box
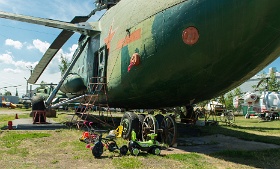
[161,134,280,154]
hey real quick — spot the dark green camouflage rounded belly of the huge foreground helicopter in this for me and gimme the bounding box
[104,0,280,108]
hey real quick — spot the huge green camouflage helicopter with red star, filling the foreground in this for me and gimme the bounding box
[0,0,280,109]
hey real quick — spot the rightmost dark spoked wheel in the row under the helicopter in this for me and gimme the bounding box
[161,116,177,146]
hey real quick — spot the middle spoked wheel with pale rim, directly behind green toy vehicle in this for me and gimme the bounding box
[142,114,158,140]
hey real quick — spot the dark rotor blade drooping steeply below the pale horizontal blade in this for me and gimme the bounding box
[28,16,89,84]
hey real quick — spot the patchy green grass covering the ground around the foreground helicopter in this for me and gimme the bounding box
[0,109,280,168]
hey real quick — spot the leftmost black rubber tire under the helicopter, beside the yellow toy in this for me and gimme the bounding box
[121,112,139,139]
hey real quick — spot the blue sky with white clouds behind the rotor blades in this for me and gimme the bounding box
[0,0,280,96]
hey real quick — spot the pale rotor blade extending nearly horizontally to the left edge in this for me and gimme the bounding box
[0,11,100,36]
